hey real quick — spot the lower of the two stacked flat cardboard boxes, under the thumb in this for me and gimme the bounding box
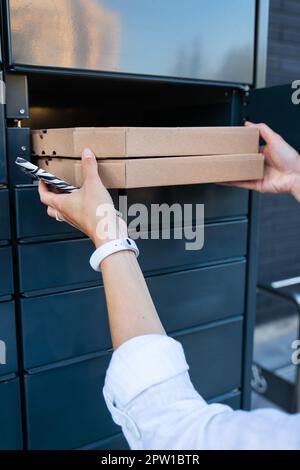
[37,153,264,189]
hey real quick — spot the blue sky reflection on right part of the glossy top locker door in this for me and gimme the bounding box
[97,0,255,82]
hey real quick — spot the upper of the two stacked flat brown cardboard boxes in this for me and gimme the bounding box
[32,127,259,158]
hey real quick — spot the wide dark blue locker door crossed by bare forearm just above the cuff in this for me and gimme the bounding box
[21,261,246,370]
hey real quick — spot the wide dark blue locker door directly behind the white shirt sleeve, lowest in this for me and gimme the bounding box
[25,318,242,450]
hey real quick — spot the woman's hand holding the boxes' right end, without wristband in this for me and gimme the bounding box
[230,122,300,202]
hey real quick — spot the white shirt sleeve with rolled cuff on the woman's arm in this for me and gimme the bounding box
[103,335,300,450]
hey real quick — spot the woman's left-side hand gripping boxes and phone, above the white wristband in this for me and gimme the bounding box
[39,149,127,247]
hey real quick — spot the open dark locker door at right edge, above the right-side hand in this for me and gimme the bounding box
[245,83,300,152]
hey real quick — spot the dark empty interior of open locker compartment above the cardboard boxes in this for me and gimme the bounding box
[27,73,244,129]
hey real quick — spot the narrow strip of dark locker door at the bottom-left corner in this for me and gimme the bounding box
[0,379,22,450]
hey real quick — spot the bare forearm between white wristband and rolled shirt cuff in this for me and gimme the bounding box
[101,251,165,349]
